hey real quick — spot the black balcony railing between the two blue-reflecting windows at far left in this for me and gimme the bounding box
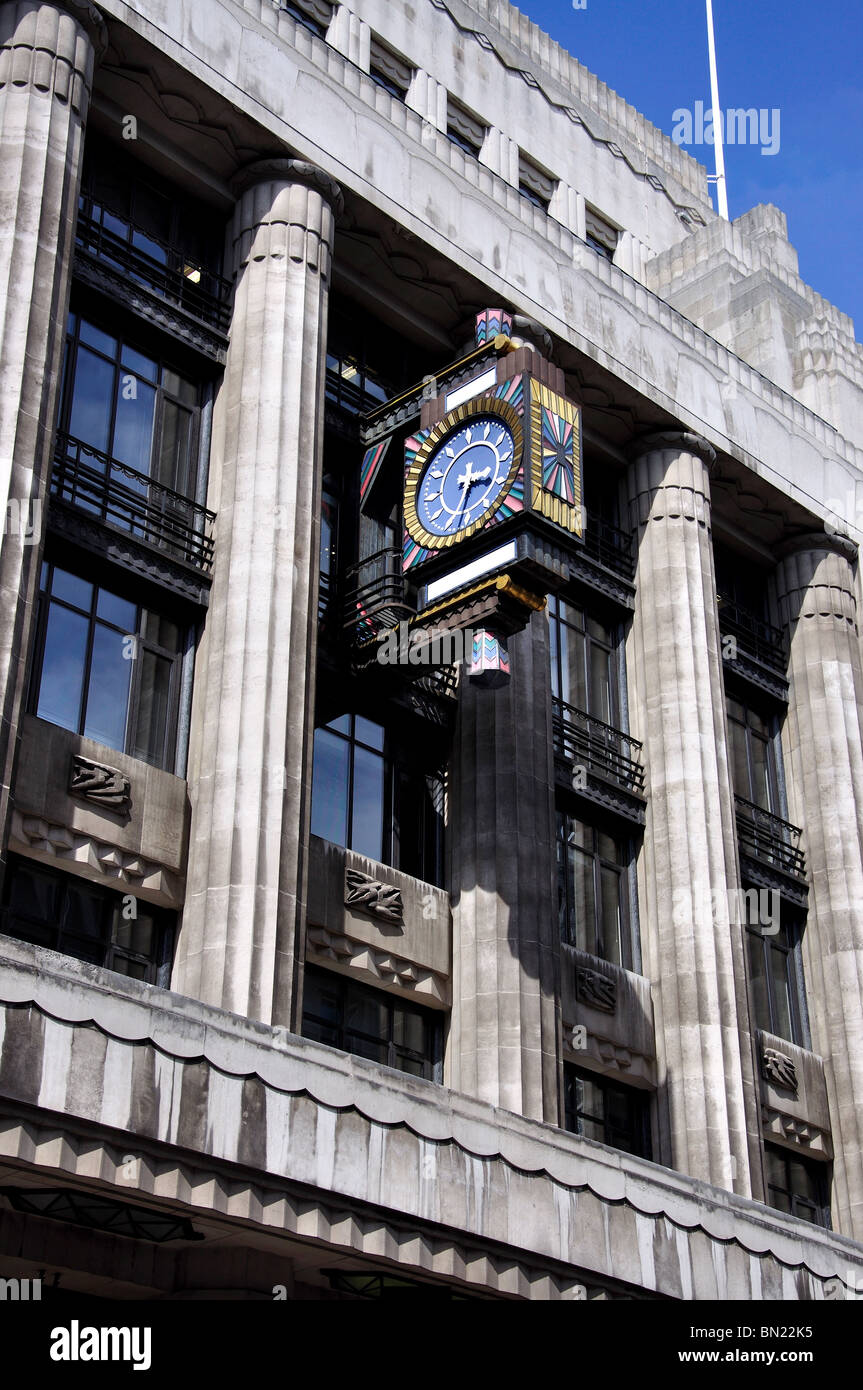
[51,434,215,570]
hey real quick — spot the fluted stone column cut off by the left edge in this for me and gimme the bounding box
[0,0,107,852]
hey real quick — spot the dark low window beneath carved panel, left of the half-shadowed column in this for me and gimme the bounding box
[303,966,441,1081]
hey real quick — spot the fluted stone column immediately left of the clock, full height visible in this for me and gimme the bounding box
[174,160,340,1026]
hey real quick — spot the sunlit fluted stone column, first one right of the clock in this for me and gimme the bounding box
[627,434,762,1197]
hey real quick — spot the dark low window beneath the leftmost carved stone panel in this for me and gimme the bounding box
[3,858,176,987]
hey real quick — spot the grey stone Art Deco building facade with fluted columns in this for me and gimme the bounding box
[0,0,863,1300]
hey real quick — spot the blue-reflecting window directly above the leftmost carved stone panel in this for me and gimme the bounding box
[32,563,185,769]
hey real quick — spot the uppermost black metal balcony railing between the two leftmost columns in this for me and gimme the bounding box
[75,200,231,334]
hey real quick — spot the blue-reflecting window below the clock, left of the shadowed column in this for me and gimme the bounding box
[311,714,443,884]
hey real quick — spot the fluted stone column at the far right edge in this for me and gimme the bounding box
[774,535,863,1240]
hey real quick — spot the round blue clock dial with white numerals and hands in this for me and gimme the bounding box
[417,416,516,537]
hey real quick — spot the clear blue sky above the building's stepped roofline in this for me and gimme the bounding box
[520,0,863,339]
